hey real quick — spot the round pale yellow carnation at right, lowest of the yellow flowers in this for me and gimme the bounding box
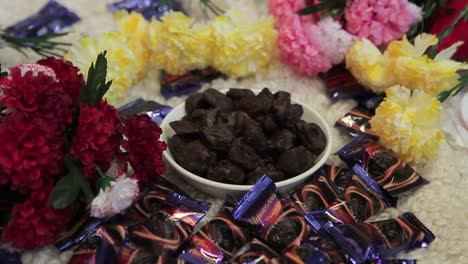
[371,85,444,162]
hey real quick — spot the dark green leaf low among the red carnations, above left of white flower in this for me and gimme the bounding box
[49,172,80,209]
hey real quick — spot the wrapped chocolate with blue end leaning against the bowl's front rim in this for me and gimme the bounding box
[233,176,311,253]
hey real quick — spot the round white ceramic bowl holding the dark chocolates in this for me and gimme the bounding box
[161,90,332,197]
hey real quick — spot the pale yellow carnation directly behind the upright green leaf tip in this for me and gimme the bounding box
[65,32,149,103]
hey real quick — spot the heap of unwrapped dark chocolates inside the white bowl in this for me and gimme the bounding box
[169,88,327,185]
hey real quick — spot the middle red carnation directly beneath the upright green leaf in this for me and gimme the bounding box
[71,101,122,177]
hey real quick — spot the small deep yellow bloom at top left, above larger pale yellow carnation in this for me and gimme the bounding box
[115,11,149,48]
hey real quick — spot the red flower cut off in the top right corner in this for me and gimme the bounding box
[431,0,468,60]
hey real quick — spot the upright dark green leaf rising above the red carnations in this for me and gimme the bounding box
[80,51,112,106]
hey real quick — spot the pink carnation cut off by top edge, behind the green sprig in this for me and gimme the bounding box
[268,0,320,26]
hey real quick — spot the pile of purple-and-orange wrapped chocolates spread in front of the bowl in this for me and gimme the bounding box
[57,134,435,264]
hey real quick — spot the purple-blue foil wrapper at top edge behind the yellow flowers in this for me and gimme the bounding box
[107,0,182,21]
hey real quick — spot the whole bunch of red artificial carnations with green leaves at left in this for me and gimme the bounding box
[0,52,166,249]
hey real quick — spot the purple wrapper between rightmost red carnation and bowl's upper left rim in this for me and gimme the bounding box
[118,98,172,125]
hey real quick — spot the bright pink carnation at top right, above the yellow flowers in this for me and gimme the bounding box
[345,0,422,46]
